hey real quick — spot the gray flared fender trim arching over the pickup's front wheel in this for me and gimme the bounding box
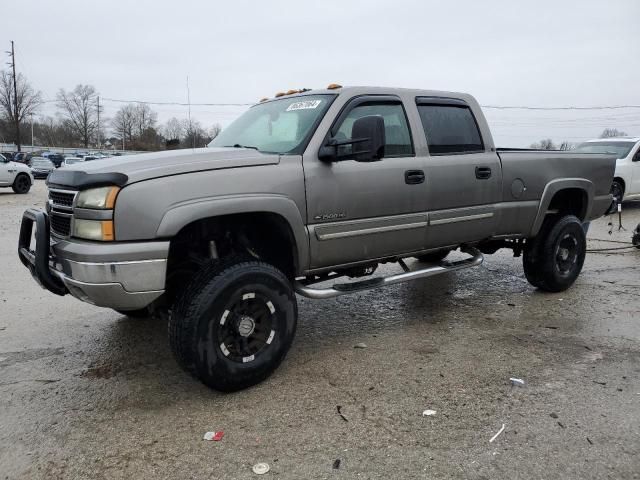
[156,194,309,271]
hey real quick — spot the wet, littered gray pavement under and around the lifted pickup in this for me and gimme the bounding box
[0,181,640,479]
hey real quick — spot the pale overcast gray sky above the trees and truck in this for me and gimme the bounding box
[0,0,640,146]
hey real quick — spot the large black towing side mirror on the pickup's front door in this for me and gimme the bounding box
[318,115,386,162]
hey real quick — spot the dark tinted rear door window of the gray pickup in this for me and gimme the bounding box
[416,97,484,155]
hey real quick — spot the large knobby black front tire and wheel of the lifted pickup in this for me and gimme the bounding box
[169,259,298,392]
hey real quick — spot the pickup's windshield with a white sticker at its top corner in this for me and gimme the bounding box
[209,95,336,155]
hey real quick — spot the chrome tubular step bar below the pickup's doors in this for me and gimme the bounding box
[293,247,484,300]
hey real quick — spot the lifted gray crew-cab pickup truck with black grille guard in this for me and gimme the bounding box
[19,85,615,391]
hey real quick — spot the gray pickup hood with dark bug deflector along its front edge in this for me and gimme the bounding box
[47,148,280,189]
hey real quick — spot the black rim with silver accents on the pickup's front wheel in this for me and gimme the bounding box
[215,292,276,363]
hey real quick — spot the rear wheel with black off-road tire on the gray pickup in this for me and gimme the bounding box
[522,215,587,292]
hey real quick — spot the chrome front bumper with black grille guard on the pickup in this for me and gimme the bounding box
[18,209,169,310]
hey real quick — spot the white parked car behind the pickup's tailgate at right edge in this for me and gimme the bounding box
[574,137,640,201]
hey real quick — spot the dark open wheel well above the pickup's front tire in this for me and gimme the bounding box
[167,212,298,294]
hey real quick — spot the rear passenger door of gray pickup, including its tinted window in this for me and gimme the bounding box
[416,97,502,248]
